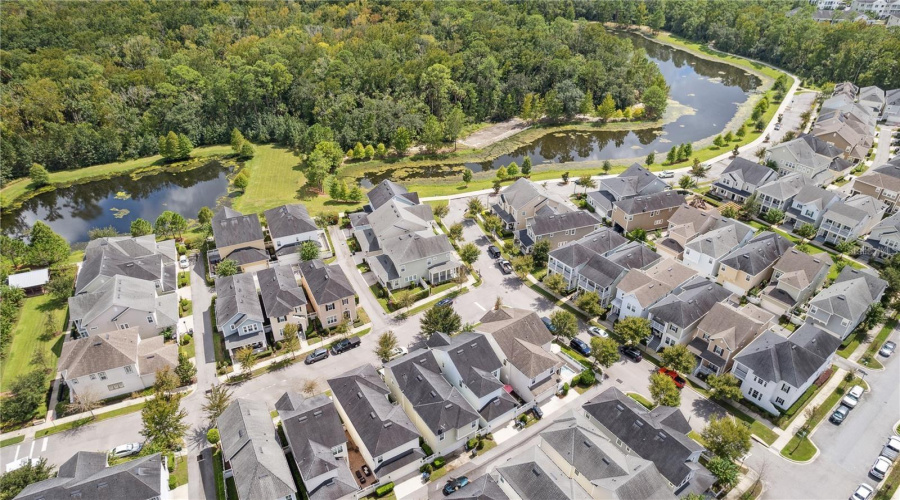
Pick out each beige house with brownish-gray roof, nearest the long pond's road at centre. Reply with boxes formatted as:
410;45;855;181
491;177;572;233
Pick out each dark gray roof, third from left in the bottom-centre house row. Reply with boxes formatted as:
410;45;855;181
328;364;419;465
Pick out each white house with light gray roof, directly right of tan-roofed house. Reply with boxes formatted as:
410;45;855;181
681;216;755;278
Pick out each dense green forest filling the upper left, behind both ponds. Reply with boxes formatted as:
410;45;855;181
0;1;665;179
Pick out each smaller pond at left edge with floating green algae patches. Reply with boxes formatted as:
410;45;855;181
0;161;228;243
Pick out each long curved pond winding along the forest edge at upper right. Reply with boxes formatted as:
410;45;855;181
360;32;760;187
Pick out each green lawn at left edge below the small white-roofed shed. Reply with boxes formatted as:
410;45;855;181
0;295;67;400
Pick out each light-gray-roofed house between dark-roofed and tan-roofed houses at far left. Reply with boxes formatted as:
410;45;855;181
69;274;178;339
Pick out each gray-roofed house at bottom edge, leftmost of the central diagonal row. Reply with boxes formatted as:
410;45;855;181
216;399;300;500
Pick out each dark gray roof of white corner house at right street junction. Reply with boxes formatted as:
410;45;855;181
735;323;841;387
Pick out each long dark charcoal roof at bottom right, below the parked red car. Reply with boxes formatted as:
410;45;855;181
582;387;703;485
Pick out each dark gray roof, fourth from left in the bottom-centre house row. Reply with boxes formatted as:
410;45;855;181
384;350;486;435
